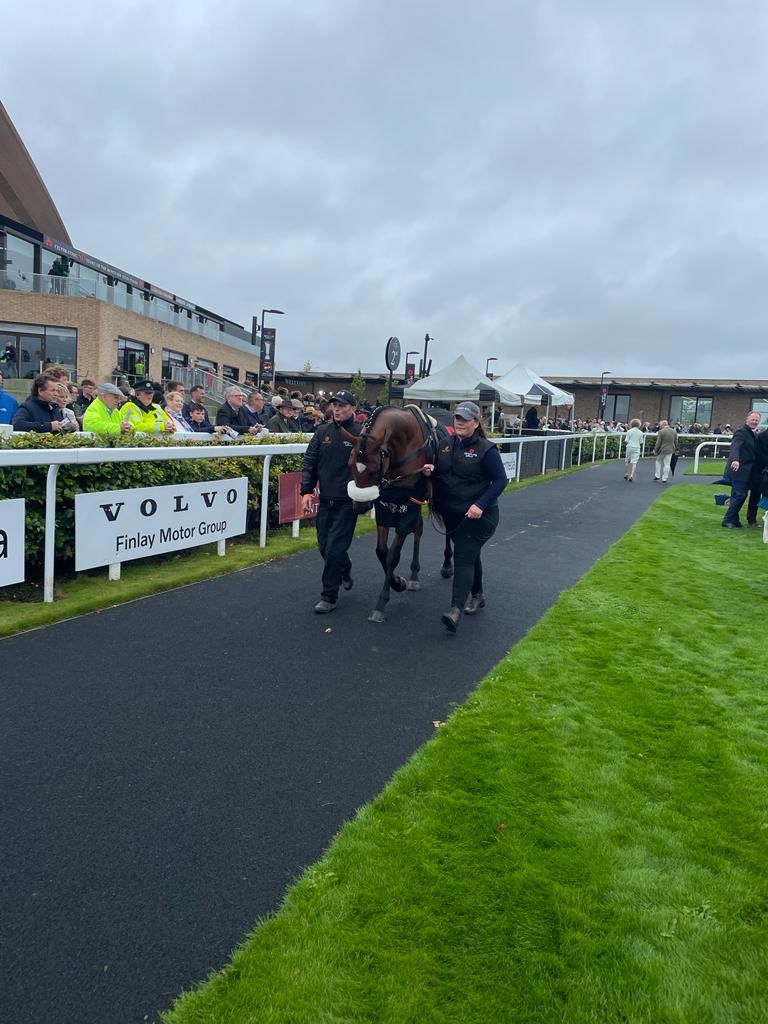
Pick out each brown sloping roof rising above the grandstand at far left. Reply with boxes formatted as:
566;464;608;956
0;102;72;245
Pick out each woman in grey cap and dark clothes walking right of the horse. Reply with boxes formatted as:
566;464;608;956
425;401;507;633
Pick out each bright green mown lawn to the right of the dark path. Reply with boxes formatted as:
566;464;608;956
166;486;768;1024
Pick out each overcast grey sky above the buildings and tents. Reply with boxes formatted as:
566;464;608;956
6;0;768;378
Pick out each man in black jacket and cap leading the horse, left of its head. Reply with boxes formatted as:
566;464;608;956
301;391;362;615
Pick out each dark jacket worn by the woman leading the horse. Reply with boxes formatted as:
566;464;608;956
435;433;507;517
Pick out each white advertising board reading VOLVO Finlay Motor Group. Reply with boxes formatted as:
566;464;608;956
75;476;248;570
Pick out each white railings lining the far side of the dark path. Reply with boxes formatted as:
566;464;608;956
0;433;730;602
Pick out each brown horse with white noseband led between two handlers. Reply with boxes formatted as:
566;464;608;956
347;406;437;623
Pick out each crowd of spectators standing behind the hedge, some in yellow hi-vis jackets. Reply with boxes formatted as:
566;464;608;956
0;366;382;438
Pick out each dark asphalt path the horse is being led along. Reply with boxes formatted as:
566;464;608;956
0;463;704;1024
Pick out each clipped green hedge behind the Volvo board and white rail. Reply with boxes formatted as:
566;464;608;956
0;434;309;579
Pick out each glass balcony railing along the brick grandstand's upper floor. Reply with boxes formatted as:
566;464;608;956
0;270;253;352
